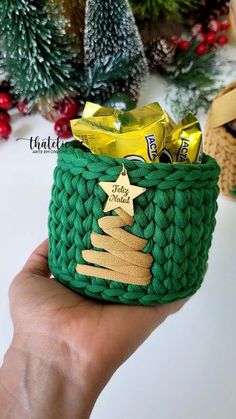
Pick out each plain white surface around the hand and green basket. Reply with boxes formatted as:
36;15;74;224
0;54;236;419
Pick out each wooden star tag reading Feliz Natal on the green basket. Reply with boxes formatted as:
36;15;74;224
99;165;146;216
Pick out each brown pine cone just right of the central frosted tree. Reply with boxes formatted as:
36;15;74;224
145;37;176;71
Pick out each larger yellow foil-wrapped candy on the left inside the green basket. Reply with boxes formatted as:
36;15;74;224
71;102;174;162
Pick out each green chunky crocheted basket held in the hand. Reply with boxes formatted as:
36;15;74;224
49;141;220;305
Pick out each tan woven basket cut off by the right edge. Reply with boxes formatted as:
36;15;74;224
204;82;236;199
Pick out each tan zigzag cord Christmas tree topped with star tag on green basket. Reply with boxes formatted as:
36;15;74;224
76;165;153;285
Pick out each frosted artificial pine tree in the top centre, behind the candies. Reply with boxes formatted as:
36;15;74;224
84;0;148;99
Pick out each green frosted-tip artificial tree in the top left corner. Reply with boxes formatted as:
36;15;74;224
0;0;76;108
